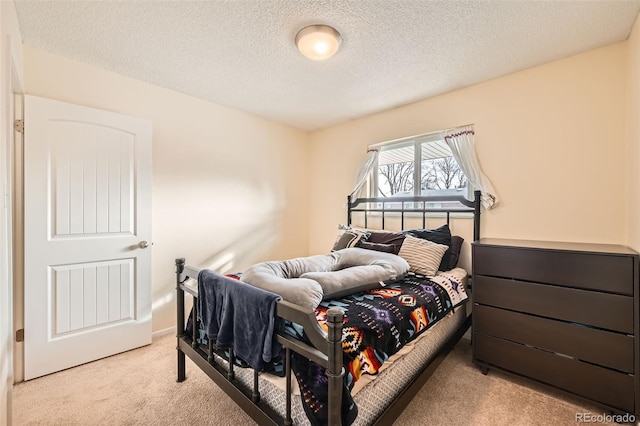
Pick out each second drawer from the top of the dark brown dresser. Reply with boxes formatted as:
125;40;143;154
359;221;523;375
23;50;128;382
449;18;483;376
473;275;634;334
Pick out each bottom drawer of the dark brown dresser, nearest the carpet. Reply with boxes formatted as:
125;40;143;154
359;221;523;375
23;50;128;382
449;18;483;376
474;333;635;413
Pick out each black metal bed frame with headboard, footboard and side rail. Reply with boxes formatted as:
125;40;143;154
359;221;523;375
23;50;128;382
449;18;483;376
176;191;480;426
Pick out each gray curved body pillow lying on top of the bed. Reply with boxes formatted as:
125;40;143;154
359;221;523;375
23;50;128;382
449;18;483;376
241;248;409;309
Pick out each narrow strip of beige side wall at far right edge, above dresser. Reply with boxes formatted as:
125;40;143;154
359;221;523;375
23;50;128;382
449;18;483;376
626;17;640;251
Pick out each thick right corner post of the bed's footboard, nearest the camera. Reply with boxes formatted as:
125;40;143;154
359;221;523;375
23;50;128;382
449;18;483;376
327;308;344;426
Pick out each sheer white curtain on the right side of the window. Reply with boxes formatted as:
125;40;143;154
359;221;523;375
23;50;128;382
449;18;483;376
444;126;498;209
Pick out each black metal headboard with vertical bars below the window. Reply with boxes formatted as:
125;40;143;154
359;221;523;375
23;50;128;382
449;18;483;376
347;191;480;241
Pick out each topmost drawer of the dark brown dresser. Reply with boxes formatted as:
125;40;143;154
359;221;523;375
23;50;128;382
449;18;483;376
473;245;634;295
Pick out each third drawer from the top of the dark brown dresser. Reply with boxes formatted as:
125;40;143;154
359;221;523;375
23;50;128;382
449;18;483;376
473;305;634;373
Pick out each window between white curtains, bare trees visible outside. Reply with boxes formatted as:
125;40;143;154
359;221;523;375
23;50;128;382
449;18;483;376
371;134;472;199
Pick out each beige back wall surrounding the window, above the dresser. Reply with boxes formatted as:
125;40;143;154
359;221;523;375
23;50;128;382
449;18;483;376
309;42;627;260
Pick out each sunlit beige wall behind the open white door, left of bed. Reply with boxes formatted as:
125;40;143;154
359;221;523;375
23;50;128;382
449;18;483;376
24;45;309;331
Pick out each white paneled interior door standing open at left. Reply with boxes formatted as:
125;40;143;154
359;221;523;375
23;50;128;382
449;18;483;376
24;96;152;380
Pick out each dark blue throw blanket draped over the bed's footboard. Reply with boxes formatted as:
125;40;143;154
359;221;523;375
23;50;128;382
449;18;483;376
198;269;281;371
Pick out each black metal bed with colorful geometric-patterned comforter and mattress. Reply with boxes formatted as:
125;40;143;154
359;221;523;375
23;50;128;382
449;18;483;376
176;191;480;425
